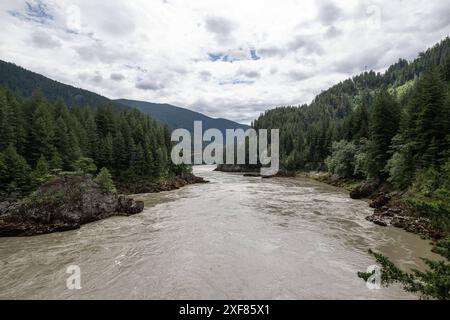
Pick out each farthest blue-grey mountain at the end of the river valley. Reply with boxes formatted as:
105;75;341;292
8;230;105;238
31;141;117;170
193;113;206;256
115;99;249;134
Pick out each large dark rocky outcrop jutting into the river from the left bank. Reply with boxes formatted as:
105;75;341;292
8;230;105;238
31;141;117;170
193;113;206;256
0;176;144;237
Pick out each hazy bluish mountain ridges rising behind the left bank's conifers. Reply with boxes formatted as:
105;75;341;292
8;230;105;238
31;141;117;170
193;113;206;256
0;60;249;132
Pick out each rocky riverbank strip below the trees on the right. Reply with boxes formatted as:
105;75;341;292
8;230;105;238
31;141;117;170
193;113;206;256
301;172;443;240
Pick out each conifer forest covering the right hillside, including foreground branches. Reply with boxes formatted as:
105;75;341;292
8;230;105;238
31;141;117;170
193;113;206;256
253;38;450;299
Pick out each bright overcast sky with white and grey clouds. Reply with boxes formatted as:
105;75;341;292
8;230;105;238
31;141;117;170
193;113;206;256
0;0;450;123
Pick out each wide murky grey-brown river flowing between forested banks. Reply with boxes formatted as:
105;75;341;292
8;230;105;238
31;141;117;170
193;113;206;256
0;166;434;299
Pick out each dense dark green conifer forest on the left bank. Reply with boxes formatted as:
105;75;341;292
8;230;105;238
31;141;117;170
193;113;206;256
0;88;187;199
